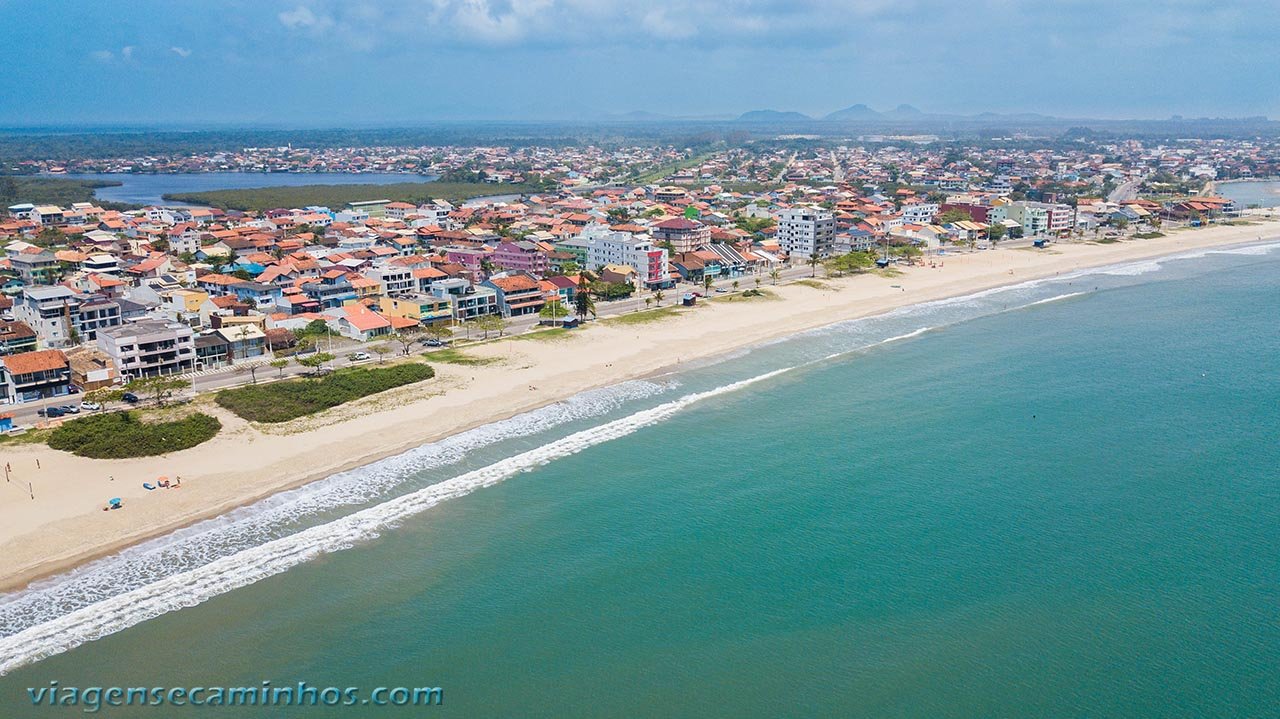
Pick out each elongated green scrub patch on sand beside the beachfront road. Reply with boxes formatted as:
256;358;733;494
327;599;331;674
215;365;435;422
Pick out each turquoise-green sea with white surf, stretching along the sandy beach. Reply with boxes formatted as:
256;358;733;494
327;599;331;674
0;243;1280;716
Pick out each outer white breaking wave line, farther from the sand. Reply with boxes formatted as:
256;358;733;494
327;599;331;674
0;367;795;676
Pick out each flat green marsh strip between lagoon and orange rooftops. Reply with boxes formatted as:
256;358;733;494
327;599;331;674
164;182;543;211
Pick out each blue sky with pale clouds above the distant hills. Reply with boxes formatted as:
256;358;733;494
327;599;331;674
0;0;1280;127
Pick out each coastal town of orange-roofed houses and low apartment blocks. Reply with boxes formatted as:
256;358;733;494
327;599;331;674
0;138;1276;431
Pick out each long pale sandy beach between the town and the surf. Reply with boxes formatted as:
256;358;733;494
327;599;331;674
0;224;1276;590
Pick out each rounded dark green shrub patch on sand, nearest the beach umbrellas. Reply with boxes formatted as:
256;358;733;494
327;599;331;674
49;412;223;459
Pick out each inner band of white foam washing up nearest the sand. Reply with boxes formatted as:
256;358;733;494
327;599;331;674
0;381;678;636
